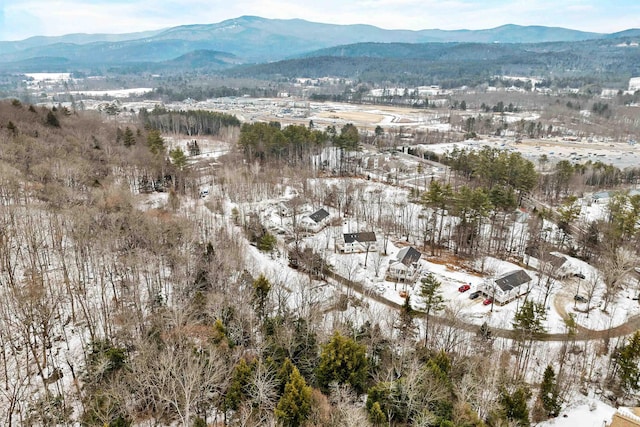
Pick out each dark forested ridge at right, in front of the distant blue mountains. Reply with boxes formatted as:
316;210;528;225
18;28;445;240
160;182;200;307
226;39;640;87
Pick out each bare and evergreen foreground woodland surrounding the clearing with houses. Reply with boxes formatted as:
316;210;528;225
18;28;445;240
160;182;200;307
0;100;640;427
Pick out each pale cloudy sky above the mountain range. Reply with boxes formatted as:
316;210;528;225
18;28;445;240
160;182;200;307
0;0;640;40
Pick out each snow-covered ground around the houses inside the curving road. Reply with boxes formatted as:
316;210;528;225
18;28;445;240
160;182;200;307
250;178;640;333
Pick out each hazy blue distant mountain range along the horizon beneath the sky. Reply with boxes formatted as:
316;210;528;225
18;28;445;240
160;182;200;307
0;16;640;72
